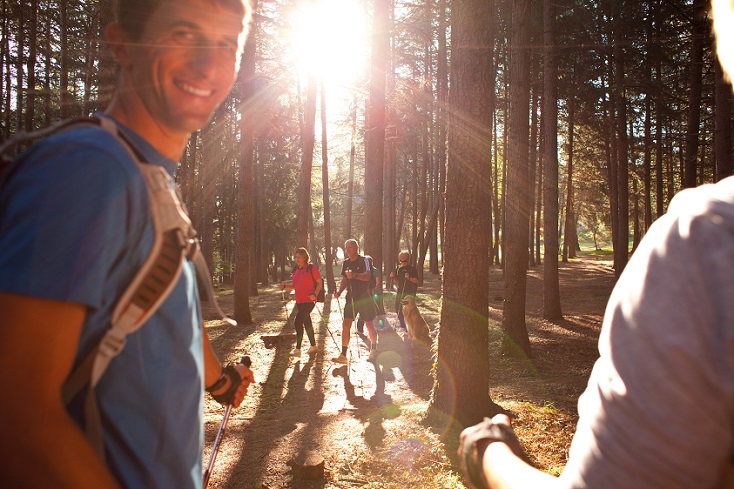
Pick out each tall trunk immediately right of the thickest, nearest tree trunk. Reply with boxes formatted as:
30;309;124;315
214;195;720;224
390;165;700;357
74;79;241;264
502;0;533;357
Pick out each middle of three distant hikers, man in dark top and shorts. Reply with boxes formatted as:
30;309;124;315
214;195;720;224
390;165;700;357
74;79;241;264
333;239;377;364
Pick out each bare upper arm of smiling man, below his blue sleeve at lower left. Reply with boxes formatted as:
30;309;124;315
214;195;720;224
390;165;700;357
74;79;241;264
0;292;118;488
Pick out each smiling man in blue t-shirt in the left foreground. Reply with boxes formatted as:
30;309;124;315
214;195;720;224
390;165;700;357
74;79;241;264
0;0;253;488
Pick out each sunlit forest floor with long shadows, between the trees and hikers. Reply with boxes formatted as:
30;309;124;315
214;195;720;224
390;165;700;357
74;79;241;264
204;253;614;489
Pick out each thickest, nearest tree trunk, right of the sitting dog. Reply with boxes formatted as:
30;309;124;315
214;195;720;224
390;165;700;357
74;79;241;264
430;0;506;425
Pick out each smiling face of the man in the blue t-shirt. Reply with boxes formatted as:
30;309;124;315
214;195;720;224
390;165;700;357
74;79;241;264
123;0;244;134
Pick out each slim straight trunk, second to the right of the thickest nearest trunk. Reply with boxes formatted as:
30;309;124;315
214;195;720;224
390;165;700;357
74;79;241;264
542;0;563;320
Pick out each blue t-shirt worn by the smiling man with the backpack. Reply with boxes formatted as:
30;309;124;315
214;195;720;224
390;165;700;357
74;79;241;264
0;117;204;488
